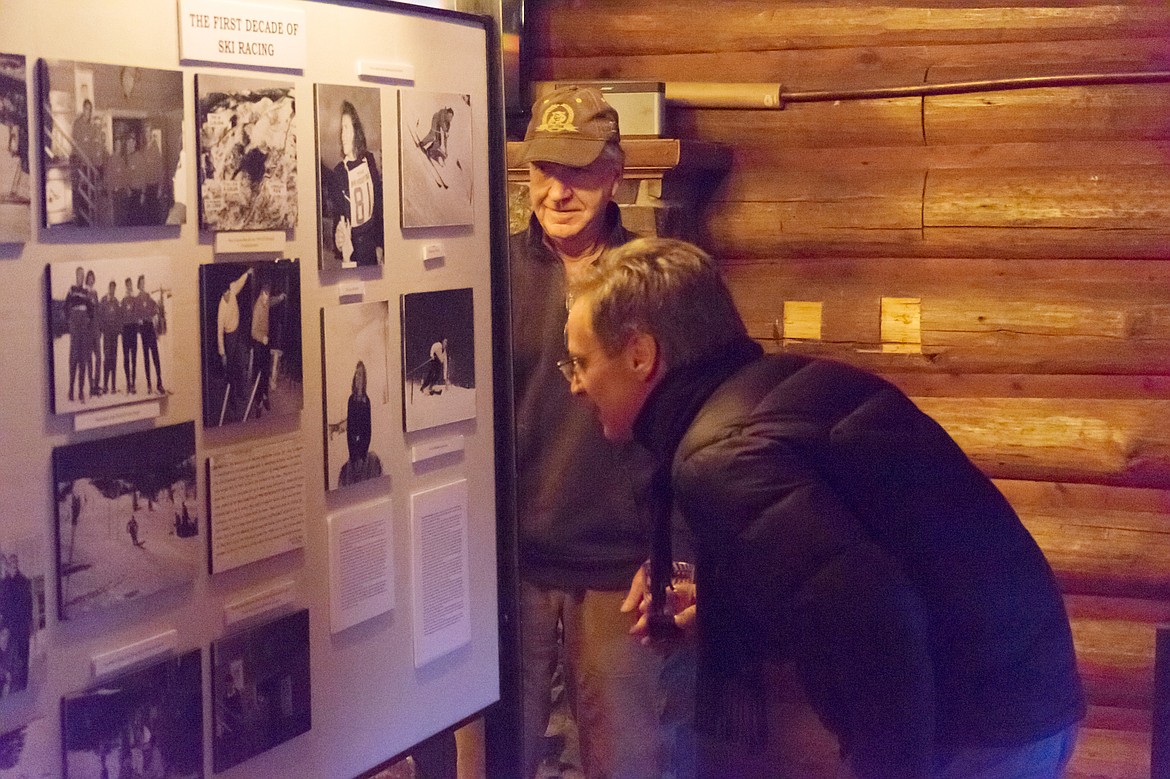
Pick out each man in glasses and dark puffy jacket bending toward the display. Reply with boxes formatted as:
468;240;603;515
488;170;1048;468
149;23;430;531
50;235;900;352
567;239;1085;779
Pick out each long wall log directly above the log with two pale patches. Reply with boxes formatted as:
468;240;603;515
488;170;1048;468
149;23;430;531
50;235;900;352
708;165;1170;257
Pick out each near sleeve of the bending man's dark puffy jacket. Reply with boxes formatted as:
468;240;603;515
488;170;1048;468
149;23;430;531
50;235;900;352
674;432;935;779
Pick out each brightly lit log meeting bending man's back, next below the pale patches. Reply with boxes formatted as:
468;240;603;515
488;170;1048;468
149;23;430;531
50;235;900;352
914;398;1170;488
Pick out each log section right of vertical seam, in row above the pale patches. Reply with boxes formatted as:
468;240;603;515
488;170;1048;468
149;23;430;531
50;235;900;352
922;164;1170;225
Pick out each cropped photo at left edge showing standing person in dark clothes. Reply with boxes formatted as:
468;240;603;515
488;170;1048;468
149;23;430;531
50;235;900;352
0;536;47;698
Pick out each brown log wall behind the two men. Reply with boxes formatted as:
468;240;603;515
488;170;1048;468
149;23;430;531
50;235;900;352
524;0;1170;779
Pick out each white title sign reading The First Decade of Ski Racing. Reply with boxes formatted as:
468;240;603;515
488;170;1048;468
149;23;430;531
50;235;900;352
179;0;307;70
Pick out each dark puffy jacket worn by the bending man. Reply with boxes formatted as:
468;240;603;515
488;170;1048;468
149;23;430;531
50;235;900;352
635;348;1085;779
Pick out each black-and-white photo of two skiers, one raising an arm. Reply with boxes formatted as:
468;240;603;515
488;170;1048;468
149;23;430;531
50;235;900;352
199;260;304;428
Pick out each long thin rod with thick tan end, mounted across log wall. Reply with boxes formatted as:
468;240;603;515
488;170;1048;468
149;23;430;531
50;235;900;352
666;70;1170;110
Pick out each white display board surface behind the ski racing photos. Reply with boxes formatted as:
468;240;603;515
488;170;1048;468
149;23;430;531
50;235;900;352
0;0;505;779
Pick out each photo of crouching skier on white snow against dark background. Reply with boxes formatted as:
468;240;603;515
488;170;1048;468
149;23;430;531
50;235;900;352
402;287;475;433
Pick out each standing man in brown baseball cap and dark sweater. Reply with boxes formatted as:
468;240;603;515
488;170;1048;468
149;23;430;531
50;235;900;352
510;87;693;779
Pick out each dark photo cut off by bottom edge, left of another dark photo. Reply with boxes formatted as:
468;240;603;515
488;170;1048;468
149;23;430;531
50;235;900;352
61;649;204;779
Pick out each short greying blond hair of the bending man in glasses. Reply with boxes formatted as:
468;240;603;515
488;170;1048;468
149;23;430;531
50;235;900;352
570;239;746;368
